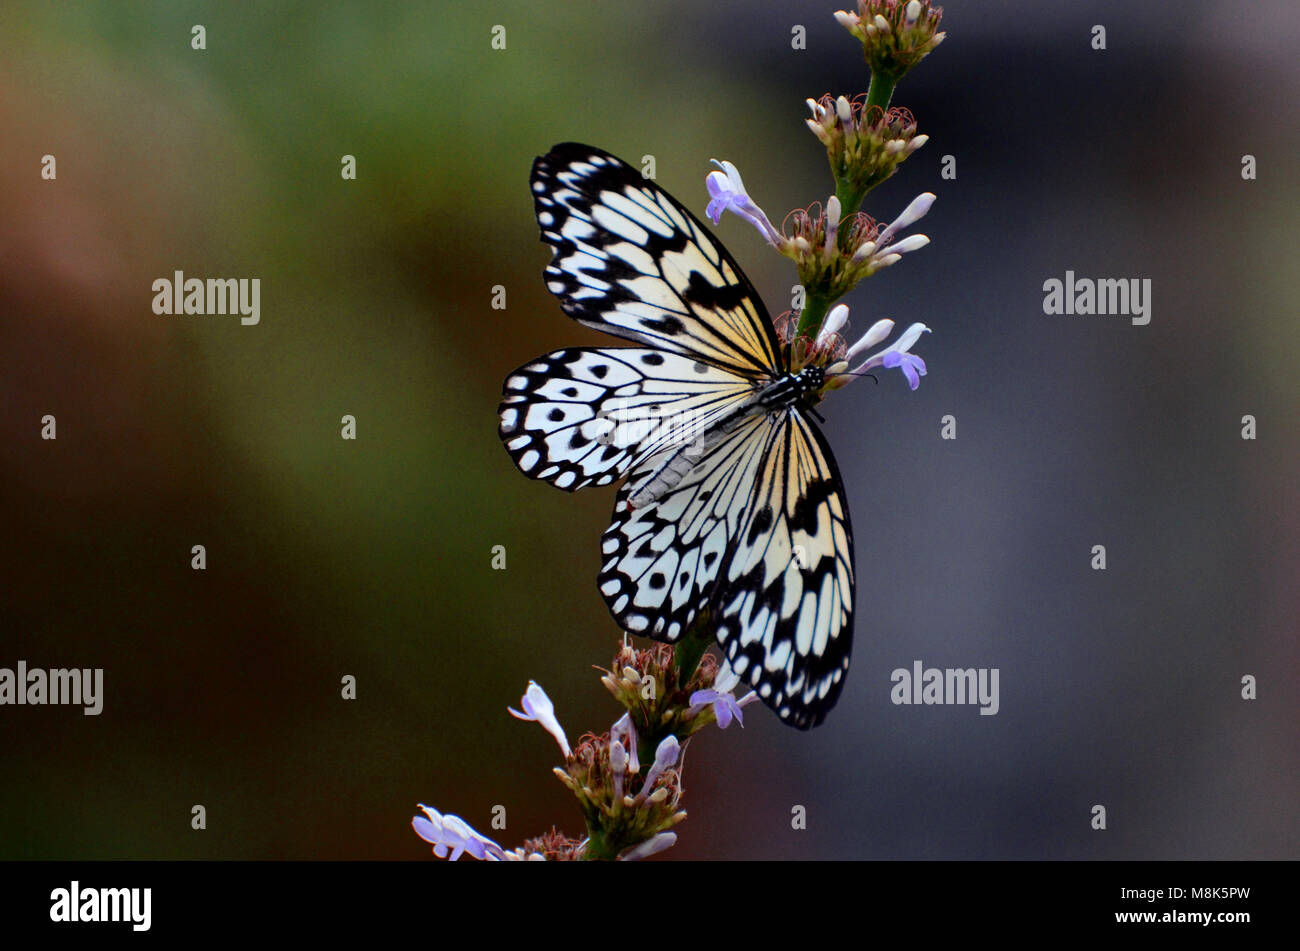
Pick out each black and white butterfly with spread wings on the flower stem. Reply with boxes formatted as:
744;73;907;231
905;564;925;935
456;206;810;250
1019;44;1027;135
501;143;854;729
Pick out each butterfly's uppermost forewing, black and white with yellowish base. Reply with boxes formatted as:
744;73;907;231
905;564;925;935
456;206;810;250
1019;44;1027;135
532;143;780;375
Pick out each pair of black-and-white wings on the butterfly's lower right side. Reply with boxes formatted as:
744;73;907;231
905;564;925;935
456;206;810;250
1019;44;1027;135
598;408;854;729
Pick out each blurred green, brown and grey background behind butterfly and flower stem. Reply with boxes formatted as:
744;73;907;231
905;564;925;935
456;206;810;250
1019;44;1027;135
0;0;1300;859
